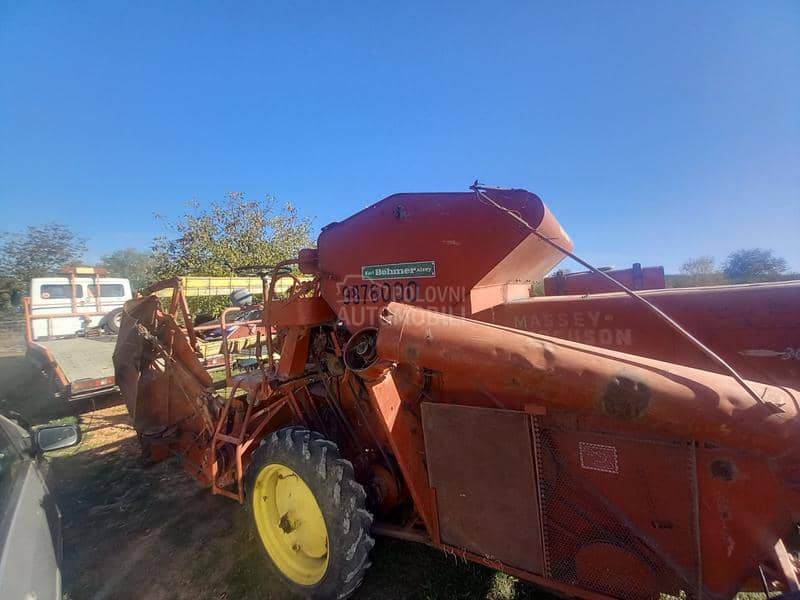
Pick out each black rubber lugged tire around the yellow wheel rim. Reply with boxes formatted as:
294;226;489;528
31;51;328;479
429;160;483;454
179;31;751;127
245;427;375;600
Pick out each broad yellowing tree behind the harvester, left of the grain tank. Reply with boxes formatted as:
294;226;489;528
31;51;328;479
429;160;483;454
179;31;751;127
153;192;311;279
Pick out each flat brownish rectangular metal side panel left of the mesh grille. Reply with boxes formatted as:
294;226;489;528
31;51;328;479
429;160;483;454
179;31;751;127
422;403;544;574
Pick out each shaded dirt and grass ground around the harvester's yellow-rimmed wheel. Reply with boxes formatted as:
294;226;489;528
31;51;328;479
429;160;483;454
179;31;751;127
0;355;549;600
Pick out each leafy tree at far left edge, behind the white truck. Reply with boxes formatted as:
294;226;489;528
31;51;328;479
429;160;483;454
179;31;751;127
0;223;86;303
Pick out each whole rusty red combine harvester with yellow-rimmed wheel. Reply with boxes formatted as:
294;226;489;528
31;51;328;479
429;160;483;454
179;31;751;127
115;186;800;598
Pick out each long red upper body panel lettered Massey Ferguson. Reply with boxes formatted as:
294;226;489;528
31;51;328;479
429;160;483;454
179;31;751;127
472;281;800;387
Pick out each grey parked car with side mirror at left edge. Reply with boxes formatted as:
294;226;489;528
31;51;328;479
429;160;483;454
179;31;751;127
0;415;80;600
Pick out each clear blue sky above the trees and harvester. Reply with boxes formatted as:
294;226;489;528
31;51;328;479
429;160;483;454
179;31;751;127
0;0;800;270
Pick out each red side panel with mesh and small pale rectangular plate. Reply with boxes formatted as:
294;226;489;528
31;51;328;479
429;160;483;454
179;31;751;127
533;416;703;600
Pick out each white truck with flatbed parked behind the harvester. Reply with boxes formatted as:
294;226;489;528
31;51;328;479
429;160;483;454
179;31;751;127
23;267;132;400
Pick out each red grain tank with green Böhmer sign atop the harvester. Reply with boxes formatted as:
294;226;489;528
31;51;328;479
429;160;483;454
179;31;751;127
312;190;572;331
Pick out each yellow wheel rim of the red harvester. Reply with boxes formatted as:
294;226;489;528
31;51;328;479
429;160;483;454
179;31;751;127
253;463;328;585
